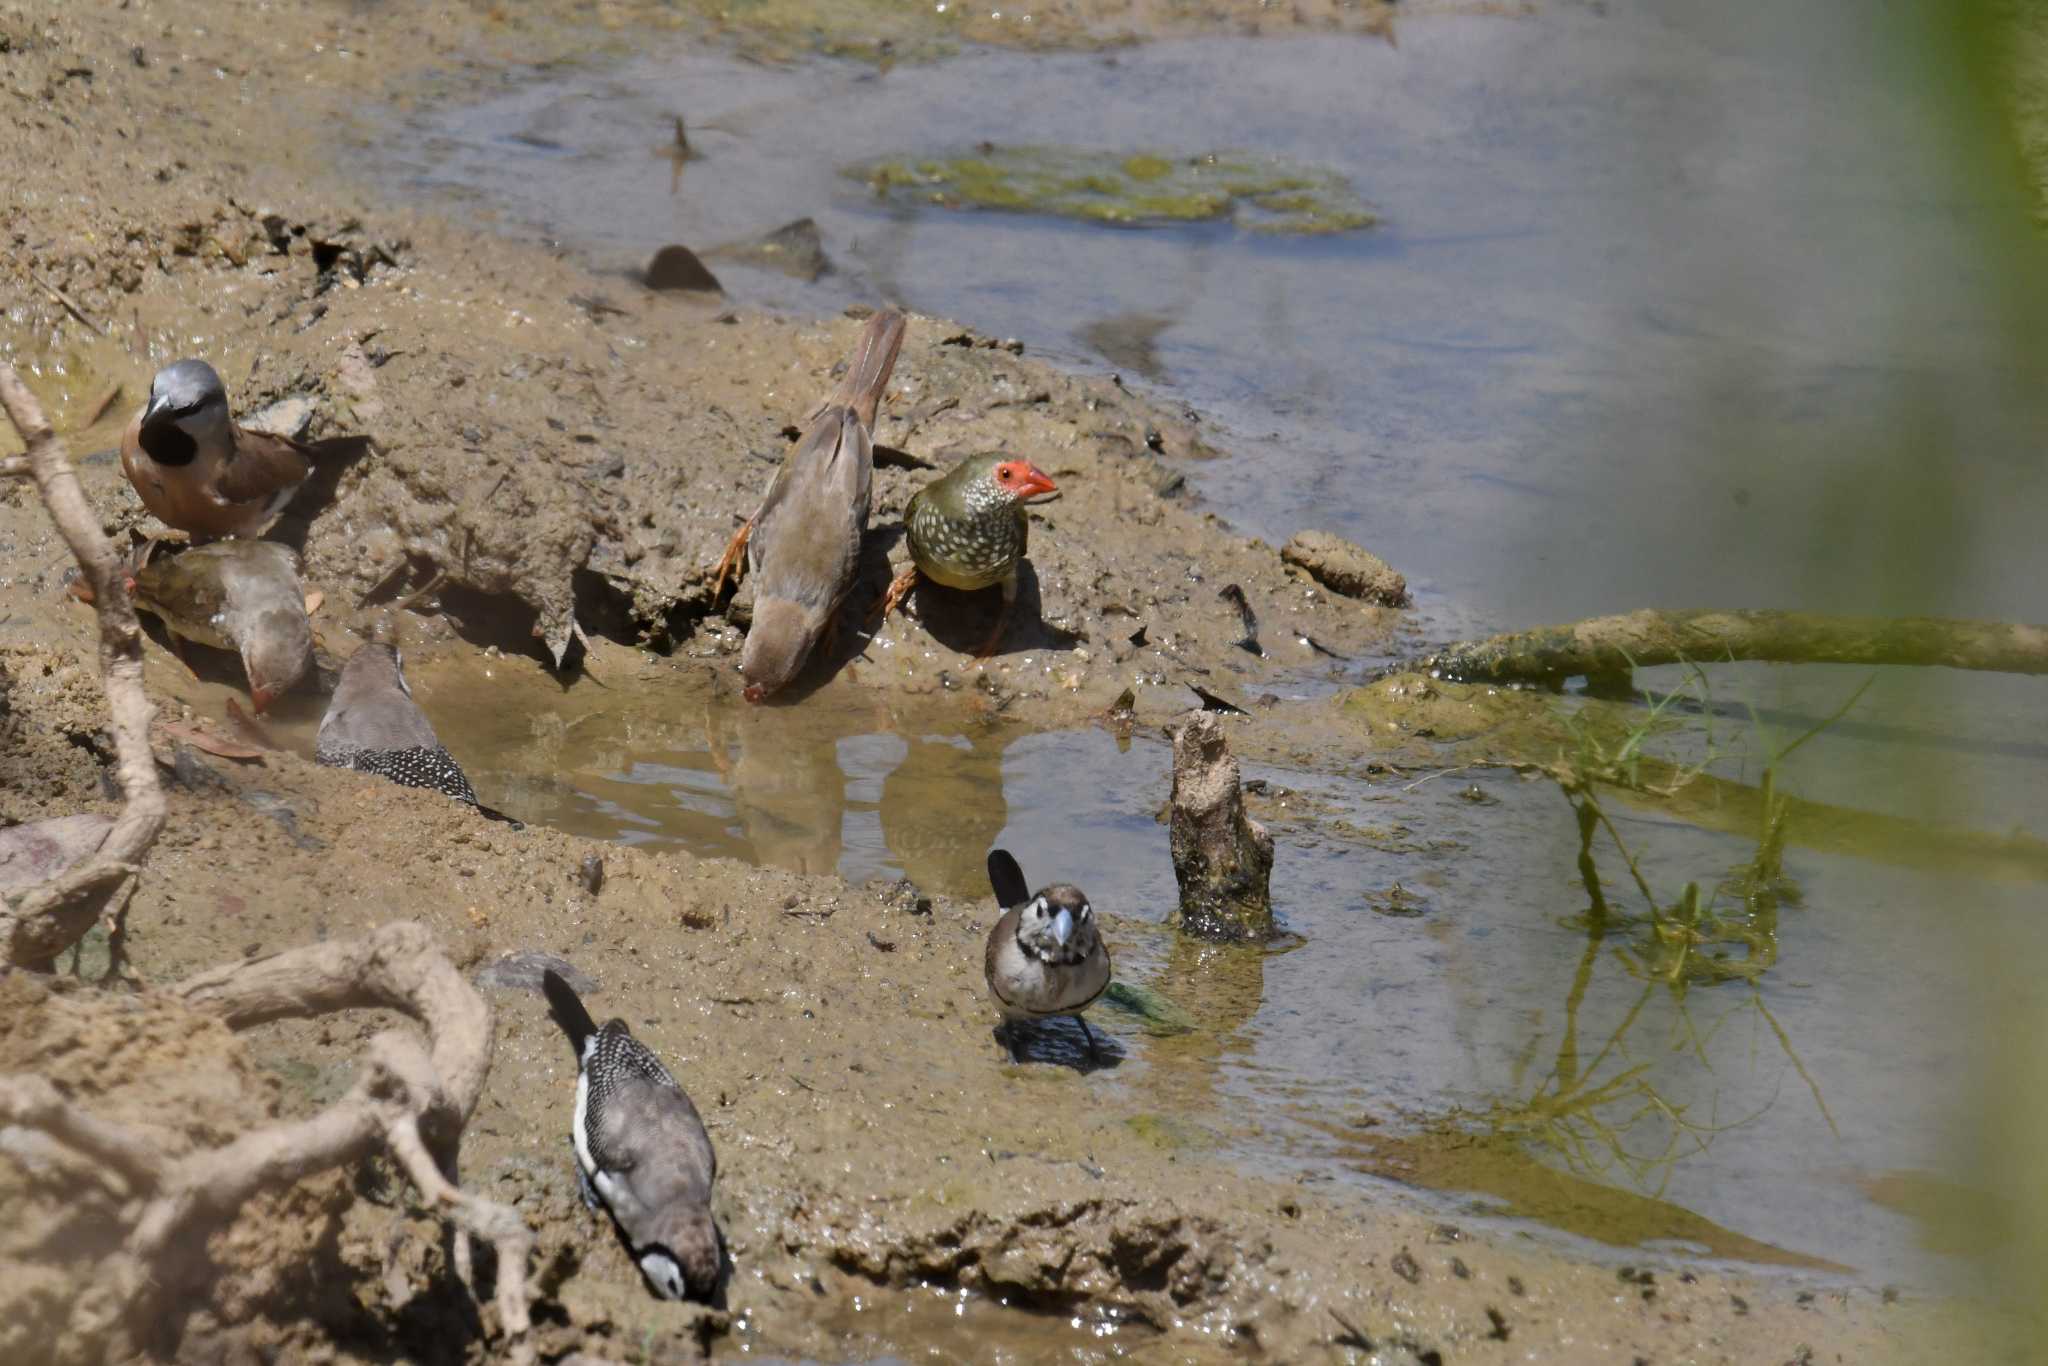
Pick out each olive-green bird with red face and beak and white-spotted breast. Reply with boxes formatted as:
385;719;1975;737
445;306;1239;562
877;453;1059;659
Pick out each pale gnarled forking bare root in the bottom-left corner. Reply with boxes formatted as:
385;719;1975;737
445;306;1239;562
0;924;537;1362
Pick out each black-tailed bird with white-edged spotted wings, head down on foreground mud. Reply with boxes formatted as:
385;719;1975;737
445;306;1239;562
541;969;723;1300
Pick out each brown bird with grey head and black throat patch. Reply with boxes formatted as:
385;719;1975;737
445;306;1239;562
121;358;313;537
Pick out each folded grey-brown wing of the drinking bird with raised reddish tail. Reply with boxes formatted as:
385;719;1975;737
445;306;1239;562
748;405;874;606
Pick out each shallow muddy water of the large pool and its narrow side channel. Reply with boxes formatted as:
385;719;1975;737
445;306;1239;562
352;4;2048;1282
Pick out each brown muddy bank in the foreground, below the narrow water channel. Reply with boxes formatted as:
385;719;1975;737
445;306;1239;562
6;720;1990;1362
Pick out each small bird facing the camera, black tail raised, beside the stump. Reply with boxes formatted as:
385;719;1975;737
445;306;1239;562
981;850;1110;1061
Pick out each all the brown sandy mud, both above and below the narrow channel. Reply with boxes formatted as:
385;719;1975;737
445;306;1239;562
0;0;1998;1362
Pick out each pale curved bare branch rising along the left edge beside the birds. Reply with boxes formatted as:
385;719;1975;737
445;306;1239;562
0;365;164;967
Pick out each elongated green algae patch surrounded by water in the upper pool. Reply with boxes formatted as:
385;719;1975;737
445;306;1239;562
846;143;1378;236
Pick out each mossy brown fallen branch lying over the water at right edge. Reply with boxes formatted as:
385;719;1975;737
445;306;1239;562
1419;608;2048;686
